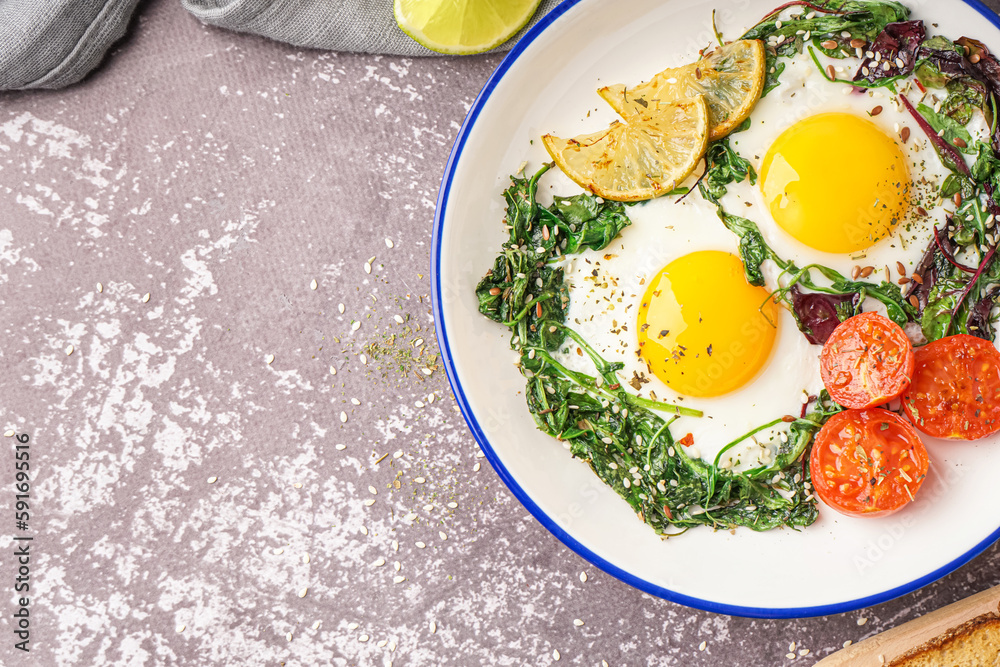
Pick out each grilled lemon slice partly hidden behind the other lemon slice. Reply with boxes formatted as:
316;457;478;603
597;39;766;141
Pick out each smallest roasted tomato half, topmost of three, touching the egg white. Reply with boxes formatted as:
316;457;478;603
820;313;914;409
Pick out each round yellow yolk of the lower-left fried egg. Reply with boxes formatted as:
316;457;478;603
637;250;778;396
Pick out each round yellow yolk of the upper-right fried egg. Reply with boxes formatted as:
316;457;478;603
760;113;910;253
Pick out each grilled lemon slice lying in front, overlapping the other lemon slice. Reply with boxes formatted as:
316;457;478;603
542;97;708;201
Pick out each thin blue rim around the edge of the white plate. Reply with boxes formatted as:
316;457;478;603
430;0;1000;619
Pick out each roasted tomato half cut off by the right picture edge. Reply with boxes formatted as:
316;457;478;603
903;334;1000;440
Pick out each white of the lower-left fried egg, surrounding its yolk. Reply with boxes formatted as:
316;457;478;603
562;195;823;472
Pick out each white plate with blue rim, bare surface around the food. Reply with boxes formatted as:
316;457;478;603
431;0;1000;618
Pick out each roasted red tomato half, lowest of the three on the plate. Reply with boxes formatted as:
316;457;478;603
809;408;930;516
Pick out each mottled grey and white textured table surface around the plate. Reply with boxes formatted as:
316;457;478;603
0;0;1000;666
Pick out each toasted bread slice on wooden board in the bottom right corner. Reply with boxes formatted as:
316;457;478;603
889;614;1000;667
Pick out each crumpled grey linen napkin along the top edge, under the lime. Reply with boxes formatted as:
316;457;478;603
0;0;559;90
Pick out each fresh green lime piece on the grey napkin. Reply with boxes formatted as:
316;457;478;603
393;0;541;55
